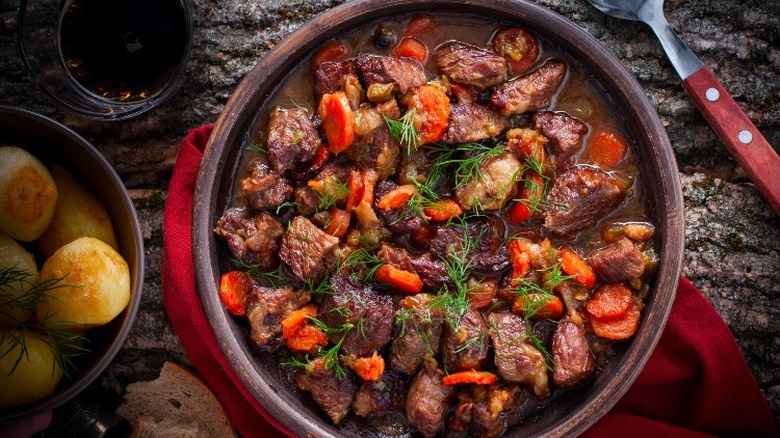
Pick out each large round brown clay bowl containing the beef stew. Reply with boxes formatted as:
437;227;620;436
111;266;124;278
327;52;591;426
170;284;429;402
193;0;683;437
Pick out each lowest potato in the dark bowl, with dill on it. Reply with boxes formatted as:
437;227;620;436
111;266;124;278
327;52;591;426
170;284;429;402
0;330;62;409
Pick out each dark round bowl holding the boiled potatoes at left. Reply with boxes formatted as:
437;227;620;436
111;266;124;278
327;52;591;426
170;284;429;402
0;106;144;424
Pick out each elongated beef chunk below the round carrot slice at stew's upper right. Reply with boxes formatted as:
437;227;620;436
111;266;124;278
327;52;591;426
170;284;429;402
490;59;567;117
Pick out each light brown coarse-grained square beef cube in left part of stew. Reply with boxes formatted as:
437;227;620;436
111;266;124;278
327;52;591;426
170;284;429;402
279;216;339;281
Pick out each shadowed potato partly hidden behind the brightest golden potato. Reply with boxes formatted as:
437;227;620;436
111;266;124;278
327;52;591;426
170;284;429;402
38;165;119;258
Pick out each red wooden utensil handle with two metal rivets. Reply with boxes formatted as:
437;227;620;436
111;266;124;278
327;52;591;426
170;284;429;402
683;67;780;216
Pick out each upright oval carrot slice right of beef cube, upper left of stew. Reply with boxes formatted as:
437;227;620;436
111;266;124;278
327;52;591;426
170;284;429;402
317;91;355;154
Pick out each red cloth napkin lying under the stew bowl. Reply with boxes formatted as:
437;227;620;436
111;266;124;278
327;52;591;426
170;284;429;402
162;126;778;438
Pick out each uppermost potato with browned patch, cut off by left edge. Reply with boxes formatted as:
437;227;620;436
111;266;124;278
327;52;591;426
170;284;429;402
0;146;57;242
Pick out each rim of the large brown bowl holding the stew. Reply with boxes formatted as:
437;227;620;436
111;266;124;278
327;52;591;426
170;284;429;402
192;0;684;437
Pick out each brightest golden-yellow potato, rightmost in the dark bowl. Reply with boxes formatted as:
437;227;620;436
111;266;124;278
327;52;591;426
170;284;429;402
35;237;130;331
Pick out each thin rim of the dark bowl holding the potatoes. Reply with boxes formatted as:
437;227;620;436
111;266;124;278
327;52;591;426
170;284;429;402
0;105;144;424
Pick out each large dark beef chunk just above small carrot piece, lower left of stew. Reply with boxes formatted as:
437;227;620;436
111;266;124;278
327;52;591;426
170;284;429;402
318;271;395;356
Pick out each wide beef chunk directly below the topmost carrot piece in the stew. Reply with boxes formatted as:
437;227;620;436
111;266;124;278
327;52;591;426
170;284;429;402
355;55;427;94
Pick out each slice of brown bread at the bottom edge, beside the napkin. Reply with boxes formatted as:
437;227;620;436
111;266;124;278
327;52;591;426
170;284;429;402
116;362;236;438
